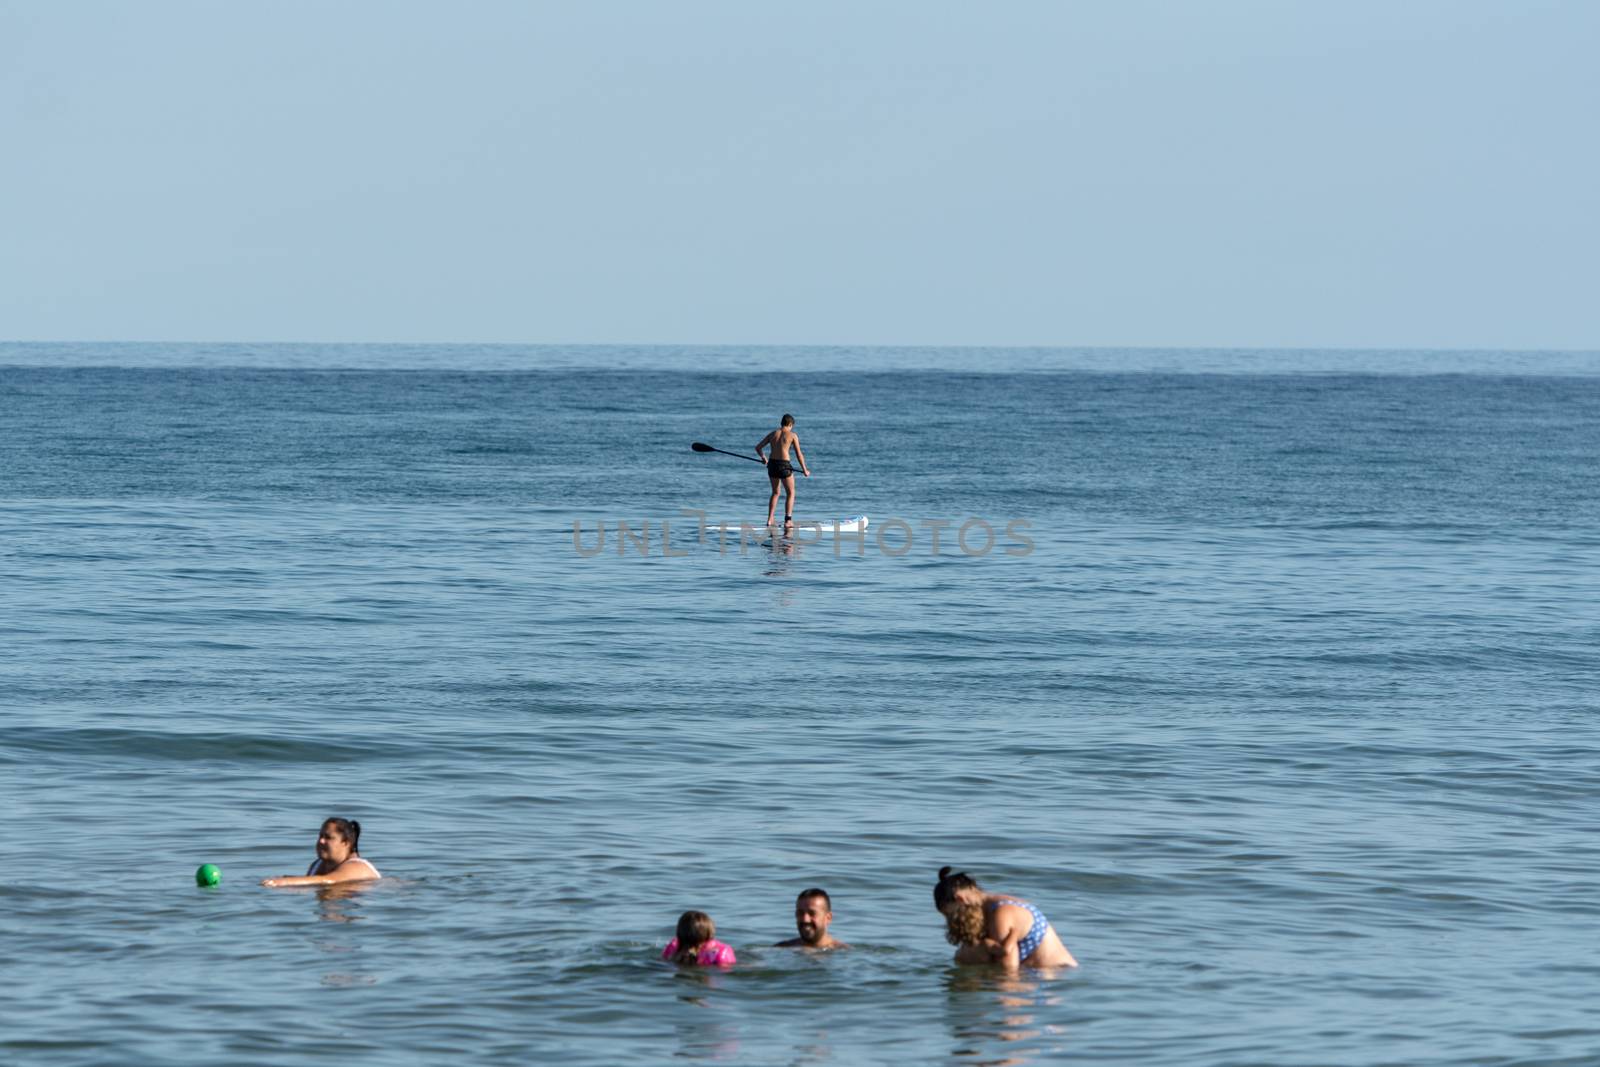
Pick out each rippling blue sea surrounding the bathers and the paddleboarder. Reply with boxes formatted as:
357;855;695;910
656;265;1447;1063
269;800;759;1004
0;342;1600;1067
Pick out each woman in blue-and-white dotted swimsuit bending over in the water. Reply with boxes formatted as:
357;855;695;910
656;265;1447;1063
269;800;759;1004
933;867;1078;968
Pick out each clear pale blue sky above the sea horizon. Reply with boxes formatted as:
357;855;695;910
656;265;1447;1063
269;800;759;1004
0;0;1600;349
